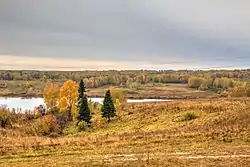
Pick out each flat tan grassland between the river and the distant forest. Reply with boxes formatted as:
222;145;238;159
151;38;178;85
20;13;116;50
0;81;219;99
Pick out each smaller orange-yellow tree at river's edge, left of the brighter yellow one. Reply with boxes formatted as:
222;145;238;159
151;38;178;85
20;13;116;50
43;83;60;109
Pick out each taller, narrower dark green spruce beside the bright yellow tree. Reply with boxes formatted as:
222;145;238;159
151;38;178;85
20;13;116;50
77;80;91;125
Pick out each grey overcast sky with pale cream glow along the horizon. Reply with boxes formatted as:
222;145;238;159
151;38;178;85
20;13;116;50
0;0;250;69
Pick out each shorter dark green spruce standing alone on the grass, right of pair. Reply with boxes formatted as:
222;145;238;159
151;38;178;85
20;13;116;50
101;90;116;122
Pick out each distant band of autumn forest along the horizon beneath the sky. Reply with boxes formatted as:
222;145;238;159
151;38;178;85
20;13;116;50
0;69;250;96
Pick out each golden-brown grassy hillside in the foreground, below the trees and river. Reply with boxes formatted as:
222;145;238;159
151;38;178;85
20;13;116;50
0;99;250;167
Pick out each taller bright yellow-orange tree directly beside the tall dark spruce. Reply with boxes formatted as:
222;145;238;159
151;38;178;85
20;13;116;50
58;80;78;119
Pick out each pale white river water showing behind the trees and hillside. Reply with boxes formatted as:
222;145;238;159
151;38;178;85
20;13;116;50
0;97;169;111
